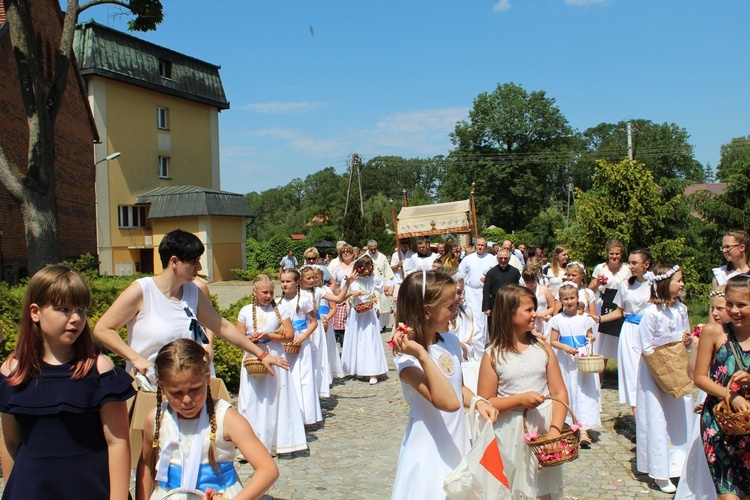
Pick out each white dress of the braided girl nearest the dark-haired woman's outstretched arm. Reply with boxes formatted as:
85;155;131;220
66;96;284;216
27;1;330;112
237;305;307;455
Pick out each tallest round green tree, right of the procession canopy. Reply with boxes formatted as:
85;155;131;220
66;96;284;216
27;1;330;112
438;83;580;230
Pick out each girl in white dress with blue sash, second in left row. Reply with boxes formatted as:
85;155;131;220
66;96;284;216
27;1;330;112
279;269;323;425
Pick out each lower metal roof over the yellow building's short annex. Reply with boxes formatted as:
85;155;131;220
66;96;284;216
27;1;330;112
140;185;255;219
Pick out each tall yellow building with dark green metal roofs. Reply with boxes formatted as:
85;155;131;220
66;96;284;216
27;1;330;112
75;21;253;281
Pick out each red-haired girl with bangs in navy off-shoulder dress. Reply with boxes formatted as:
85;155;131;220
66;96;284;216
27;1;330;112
0;266;135;500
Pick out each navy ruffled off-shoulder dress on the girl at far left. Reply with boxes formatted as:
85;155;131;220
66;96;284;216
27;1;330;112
0;363;135;500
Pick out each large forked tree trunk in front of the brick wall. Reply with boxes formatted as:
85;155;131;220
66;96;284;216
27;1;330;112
0;0;163;273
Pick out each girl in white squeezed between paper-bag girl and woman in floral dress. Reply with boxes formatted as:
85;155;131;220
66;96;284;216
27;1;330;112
675;286;731;500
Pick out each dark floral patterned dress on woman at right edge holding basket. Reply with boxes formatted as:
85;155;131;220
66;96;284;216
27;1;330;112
701;323;750;497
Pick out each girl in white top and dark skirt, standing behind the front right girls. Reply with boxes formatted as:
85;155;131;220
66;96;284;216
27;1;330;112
589;240;630;366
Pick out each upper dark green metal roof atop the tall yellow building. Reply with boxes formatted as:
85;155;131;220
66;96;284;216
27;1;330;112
73;20;229;110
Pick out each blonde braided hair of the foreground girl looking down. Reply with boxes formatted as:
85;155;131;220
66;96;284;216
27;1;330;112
149;339;219;476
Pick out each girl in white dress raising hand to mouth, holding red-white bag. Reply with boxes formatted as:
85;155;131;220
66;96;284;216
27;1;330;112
392;271;497;500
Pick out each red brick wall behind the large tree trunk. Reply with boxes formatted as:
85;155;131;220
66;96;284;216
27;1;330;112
0;0;96;278
